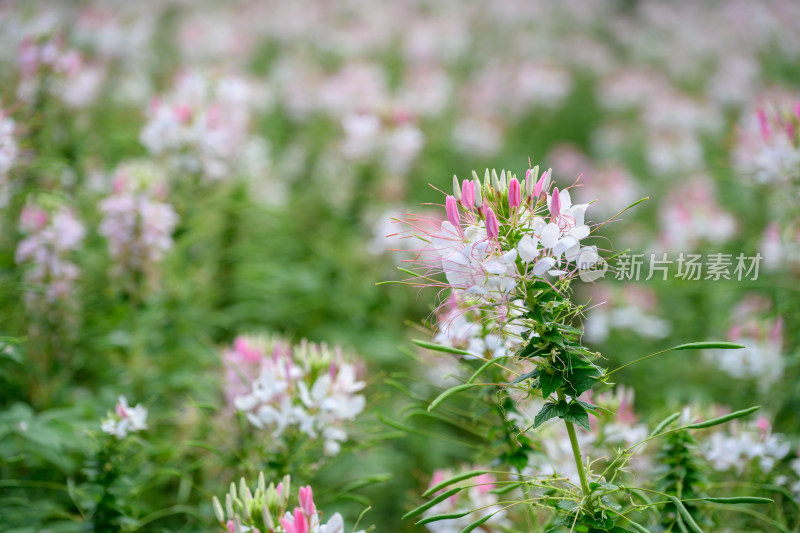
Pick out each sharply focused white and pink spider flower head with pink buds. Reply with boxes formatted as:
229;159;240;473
406;167;600;332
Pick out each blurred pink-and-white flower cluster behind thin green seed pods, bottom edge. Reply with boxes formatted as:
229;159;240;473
422;467;511;533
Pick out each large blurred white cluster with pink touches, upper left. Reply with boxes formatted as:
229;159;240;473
140;72;268;179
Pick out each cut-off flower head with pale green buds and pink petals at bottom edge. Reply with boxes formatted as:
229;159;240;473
212;472;362;533
